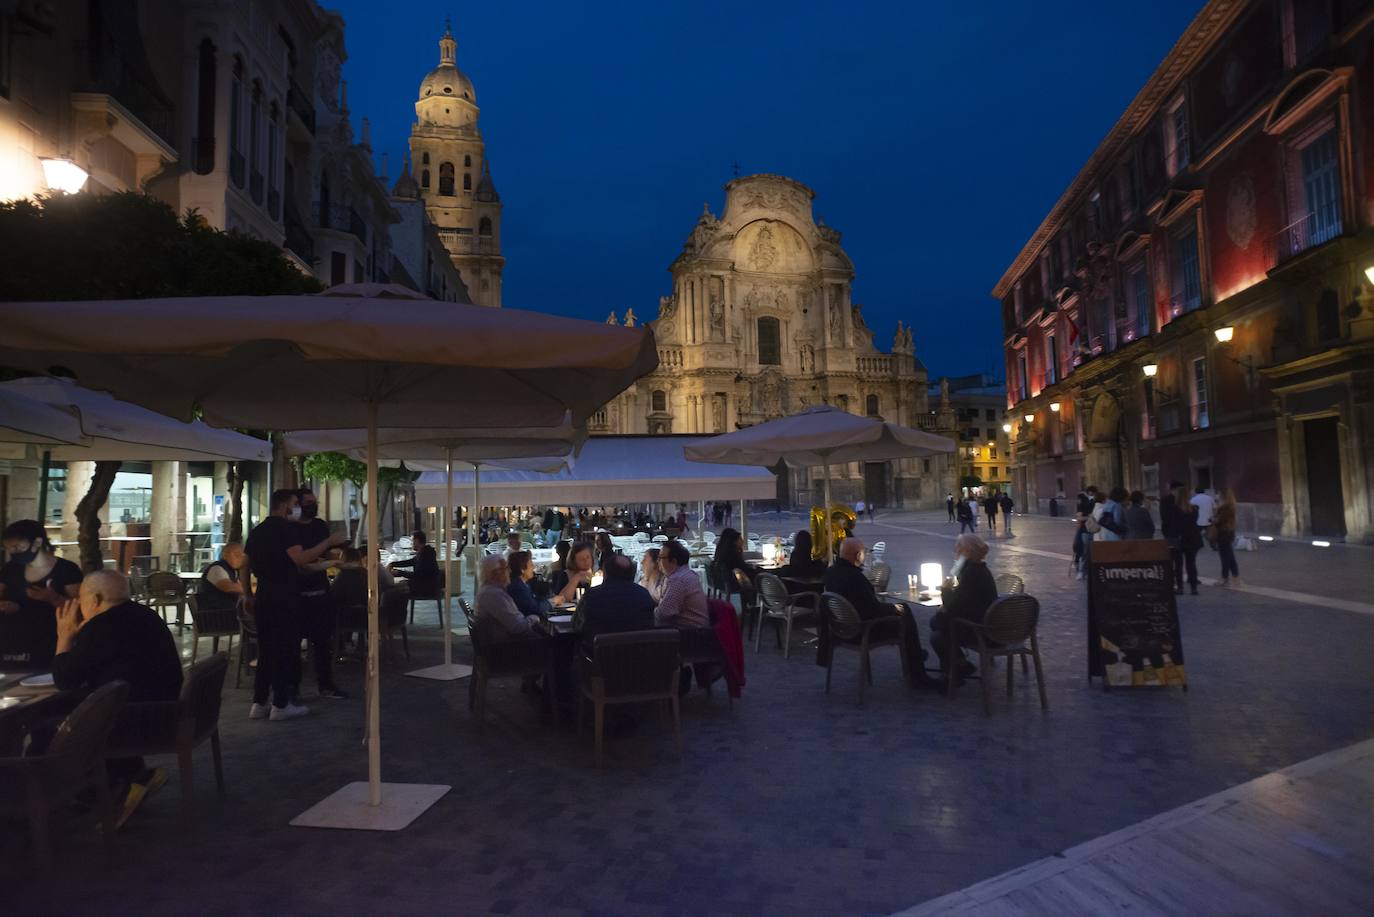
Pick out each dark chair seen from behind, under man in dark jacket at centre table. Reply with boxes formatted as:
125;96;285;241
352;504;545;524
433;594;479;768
577;627;683;767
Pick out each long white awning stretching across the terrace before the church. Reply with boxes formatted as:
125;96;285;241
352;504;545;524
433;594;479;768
415;436;778;506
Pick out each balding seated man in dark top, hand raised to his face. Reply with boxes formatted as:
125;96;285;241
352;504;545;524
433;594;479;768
52;571;181;825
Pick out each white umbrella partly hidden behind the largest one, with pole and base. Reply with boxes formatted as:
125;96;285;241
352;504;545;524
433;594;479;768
282;431;587;681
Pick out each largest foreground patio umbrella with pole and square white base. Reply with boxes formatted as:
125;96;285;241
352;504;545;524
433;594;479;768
0;296;658;830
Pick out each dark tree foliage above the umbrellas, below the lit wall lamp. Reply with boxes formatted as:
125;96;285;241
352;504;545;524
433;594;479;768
0;191;322;301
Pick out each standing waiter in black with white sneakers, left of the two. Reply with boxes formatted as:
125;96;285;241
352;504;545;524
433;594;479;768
240;489;348;720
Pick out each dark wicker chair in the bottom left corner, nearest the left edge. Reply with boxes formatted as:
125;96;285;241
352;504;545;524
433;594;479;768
0;682;129;870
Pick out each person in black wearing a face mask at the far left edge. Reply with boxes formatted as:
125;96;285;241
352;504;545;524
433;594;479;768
0;520;81;670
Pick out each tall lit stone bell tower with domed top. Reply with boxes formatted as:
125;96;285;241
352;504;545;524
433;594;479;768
411;29;506;307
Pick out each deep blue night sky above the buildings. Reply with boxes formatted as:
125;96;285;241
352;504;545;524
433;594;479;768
327;0;1202;378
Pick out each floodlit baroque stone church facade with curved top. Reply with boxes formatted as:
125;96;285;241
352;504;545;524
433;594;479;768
591;175;952;507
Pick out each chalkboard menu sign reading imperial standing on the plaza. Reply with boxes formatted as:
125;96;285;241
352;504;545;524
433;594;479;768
1088;540;1187;690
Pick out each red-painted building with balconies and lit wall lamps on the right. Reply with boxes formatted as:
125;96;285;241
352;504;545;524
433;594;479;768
993;0;1374;542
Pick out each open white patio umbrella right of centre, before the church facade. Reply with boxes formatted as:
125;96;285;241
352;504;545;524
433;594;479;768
683;404;955;560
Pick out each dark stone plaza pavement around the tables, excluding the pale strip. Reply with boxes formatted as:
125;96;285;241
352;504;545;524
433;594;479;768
0;513;1374;914
